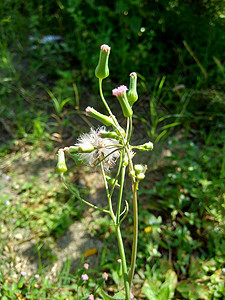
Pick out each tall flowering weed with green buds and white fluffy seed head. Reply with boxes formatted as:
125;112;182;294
56;45;153;300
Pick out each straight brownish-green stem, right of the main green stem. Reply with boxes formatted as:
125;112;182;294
129;182;138;286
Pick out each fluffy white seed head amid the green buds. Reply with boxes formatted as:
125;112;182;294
75;127;120;171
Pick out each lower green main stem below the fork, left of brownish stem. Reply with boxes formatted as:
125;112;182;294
116;226;130;300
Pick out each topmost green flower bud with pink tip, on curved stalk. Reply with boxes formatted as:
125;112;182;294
95;45;110;79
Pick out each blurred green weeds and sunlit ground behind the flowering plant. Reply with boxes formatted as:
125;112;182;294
0;0;225;300
